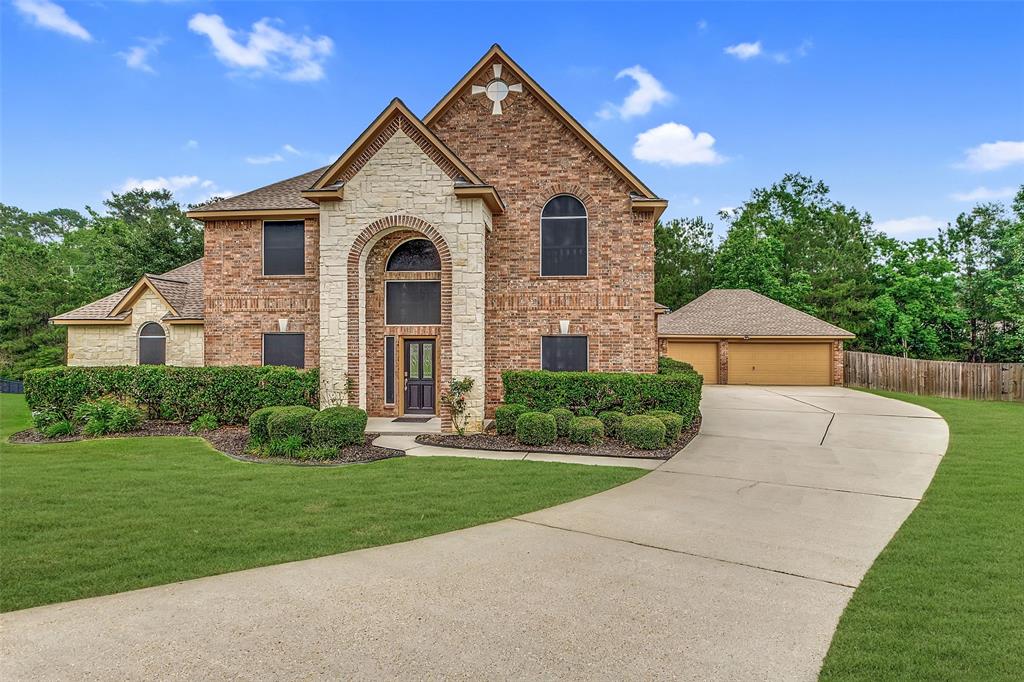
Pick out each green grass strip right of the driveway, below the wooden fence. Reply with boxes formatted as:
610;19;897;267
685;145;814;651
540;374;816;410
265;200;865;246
821;391;1024;680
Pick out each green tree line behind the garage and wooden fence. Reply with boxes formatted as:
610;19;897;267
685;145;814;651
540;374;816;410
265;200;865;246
654;173;1024;363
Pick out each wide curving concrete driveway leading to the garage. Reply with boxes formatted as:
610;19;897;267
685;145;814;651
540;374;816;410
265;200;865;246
0;386;947;680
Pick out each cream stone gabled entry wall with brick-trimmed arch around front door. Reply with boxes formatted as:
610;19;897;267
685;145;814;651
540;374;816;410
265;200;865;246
319;126;490;428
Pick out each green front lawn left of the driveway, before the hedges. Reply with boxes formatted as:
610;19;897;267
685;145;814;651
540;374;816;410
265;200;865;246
0;395;644;610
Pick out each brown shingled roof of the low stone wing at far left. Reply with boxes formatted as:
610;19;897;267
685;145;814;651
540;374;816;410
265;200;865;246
50;258;203;325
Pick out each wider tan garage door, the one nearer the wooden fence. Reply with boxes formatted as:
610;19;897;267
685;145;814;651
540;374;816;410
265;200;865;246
729;341;831;386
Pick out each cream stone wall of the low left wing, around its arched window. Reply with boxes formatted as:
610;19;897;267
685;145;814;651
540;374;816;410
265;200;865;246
68;290;203;367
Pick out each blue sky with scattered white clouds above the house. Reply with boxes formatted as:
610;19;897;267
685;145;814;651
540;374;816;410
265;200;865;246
0;0;1024;238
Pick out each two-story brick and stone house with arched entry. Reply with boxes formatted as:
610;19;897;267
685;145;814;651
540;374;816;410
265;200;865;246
54;45;667;426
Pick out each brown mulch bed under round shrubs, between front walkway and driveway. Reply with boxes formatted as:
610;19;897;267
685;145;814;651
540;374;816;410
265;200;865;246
416;415;700;460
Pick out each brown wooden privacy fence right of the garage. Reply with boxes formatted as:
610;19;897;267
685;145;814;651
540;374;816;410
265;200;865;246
843;350;1024;400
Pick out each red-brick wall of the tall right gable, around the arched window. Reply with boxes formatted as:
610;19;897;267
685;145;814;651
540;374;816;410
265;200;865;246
431;57;657;416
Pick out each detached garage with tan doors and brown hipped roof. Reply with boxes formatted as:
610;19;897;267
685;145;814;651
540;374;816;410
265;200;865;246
657;289;853;386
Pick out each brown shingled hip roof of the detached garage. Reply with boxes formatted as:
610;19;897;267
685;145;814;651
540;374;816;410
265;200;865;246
657;289;854;339
